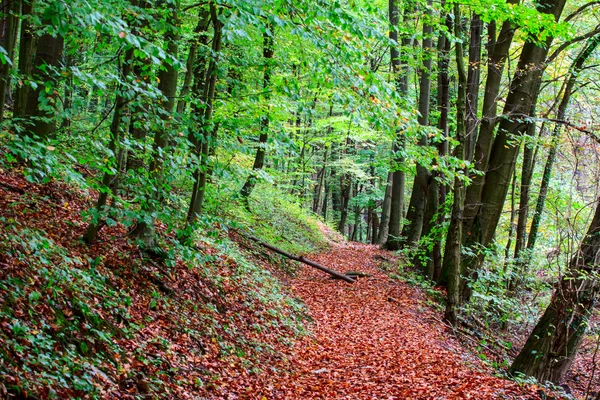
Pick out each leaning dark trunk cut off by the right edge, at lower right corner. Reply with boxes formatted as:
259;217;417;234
510;198;600;383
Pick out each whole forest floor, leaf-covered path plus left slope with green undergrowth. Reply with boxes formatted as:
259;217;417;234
0;171;595;400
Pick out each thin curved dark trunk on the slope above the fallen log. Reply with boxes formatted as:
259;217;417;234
240;24;276;209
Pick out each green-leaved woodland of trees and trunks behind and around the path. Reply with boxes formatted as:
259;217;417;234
0;0;600;397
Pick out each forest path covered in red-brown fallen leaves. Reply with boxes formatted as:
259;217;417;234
256;239;538;399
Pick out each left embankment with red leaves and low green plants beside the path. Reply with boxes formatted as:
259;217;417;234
0;170;302;399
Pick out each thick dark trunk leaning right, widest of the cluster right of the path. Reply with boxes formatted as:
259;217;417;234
462;0;565;301
